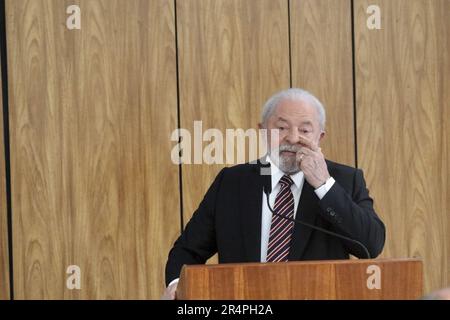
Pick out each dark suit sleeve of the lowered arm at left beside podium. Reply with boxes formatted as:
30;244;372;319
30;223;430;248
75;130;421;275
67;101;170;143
166;169;226;285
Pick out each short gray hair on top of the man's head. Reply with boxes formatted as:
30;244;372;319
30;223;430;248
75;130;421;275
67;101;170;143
261;88;325;130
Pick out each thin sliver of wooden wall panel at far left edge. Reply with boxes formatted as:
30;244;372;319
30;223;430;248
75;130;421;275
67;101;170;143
0;50;10;300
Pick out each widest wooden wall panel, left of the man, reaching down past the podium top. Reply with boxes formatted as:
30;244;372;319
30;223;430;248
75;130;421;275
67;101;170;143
6;0;180;299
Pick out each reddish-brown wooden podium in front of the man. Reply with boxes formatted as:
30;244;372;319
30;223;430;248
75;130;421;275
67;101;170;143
177;259;422;300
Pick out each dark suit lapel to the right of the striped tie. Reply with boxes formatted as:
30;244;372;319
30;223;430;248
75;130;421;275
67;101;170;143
289;180;319;261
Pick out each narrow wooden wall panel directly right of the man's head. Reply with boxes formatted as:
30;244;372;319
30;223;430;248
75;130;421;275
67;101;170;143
291;0;355;166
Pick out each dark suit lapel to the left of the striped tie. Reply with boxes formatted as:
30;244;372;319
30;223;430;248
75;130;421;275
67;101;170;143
239;164;264;262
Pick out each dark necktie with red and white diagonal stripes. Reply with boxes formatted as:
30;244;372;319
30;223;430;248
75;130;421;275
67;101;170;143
266;175;294;262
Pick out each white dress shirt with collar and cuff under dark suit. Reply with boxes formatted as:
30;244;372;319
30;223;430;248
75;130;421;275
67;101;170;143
261;157;334;262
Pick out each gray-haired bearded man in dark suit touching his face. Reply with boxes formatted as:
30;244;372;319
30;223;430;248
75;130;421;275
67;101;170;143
164;89;385;299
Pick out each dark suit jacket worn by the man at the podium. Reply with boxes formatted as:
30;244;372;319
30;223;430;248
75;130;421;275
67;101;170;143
166;160;385;284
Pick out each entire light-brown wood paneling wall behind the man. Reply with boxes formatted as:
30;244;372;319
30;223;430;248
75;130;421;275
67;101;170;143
0;0;450;299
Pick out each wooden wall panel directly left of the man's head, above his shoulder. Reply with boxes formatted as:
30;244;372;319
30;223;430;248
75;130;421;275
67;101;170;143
177;0;289;230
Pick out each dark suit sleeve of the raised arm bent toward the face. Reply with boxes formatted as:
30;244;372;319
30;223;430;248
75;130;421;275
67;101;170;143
319;169;386;258
